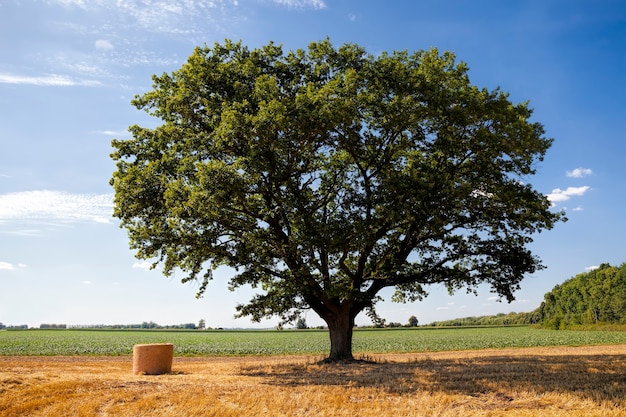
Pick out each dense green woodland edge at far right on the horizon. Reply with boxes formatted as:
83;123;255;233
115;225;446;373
536;263;626;330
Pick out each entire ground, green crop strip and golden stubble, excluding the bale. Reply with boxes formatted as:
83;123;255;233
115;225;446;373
0;327;626;417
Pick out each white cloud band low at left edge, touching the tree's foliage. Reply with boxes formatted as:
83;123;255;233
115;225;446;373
0;190;113;223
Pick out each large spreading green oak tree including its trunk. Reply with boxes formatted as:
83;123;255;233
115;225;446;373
111;39;562;360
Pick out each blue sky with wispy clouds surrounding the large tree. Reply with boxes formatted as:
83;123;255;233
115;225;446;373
0;0;626;328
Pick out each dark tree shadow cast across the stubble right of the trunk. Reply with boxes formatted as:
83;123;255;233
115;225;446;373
241;354;626;409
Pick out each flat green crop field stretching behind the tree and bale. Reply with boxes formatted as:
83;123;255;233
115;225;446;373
0;327;626;356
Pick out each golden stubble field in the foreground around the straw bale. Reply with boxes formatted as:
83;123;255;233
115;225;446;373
0;345;626;417
